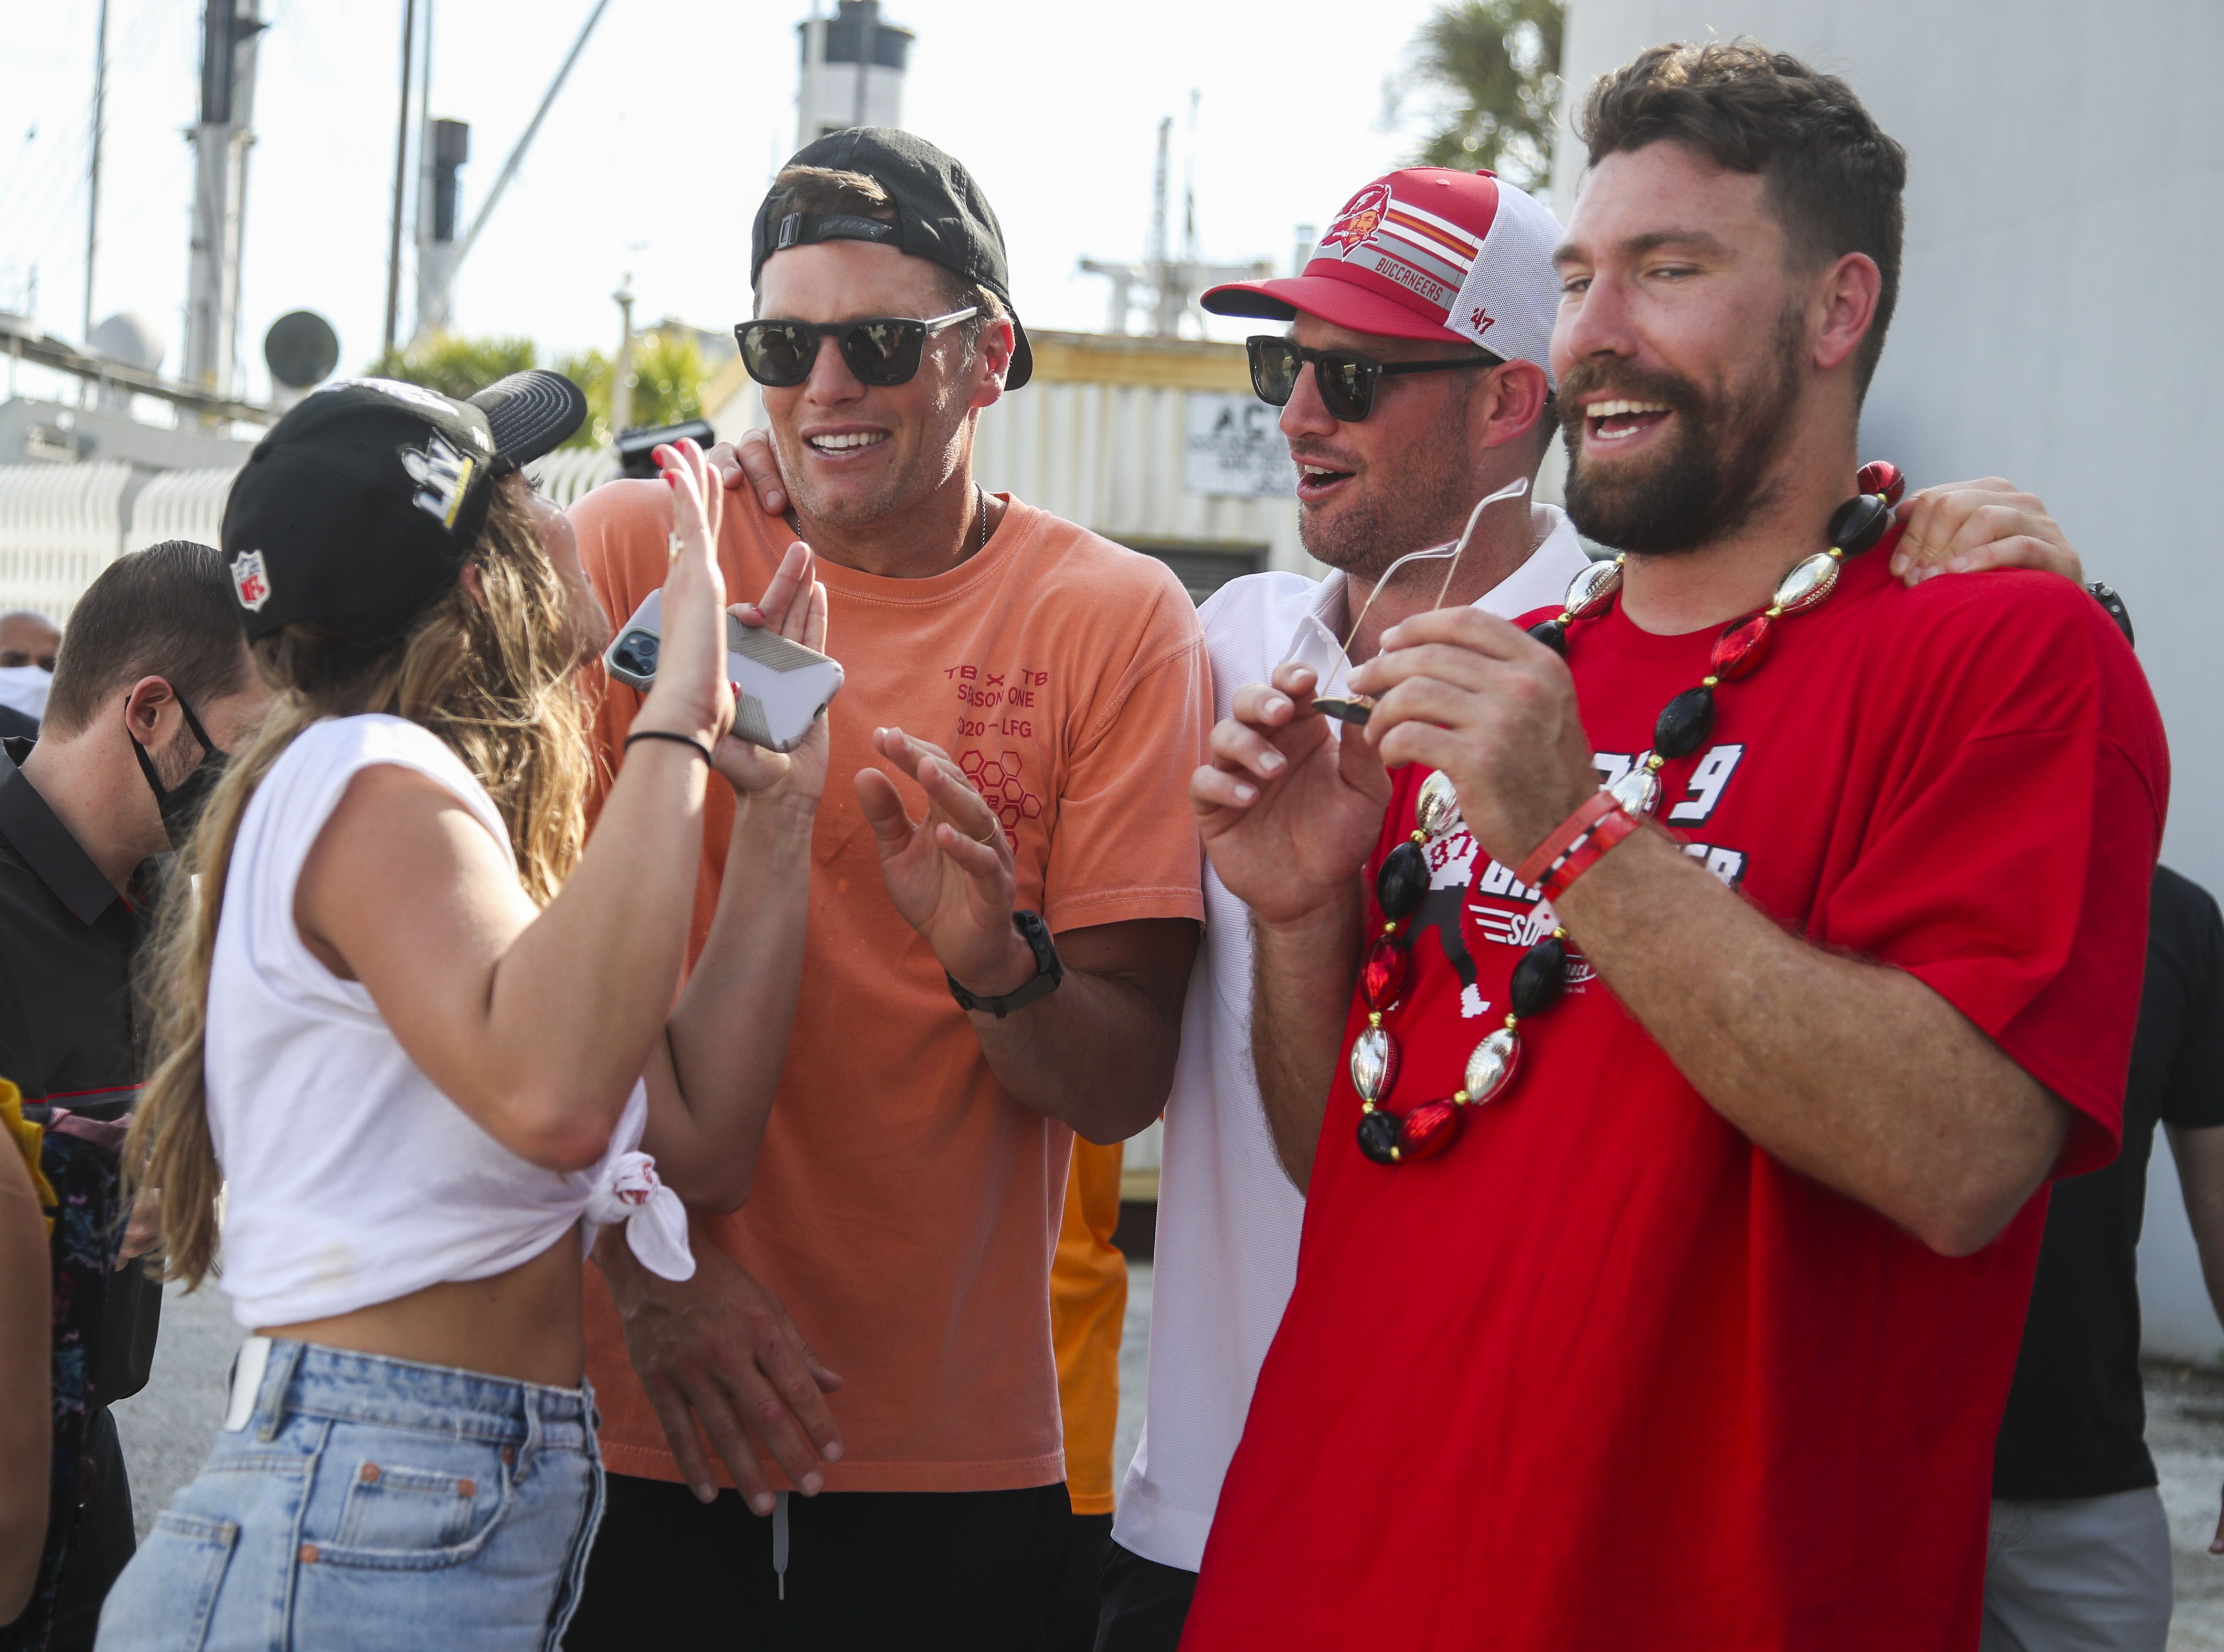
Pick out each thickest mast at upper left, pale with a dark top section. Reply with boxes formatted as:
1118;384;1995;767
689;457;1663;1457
185;0;264;407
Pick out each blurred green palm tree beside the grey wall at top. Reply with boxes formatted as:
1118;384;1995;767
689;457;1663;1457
1388;0;1563;191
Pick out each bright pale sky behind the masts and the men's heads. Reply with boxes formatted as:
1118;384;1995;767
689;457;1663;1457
0;0;1459;391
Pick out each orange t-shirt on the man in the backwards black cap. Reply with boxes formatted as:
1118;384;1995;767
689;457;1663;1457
571;483;1212;1492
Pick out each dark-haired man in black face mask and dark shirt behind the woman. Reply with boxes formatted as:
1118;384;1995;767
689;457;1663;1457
0;540;267;1652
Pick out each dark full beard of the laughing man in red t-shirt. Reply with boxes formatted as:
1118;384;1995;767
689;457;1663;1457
1559;307;1806;556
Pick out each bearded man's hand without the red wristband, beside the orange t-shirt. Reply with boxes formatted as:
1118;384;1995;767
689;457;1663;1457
1190;665;1390;938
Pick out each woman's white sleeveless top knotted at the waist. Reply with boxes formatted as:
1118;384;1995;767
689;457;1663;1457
205;716;694;1329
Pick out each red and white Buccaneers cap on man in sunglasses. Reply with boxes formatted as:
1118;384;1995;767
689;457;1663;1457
1199;167;1559;378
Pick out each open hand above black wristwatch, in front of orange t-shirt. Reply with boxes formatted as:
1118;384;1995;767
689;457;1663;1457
856;729;1036;998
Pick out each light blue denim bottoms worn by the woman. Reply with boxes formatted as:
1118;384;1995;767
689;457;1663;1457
100;1341;603;1652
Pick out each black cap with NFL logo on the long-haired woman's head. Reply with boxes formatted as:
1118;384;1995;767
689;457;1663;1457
222;369;587;649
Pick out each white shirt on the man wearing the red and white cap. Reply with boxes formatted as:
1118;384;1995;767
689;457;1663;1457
1112;505;1585;1572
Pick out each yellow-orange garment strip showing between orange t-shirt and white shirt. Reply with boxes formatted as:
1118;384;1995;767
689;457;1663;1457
1050;1136;1127;1514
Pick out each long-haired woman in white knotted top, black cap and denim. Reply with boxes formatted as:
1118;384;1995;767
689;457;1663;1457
100;374;825;1648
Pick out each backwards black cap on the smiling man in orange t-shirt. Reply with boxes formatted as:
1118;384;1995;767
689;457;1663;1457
750;127;1034;389
